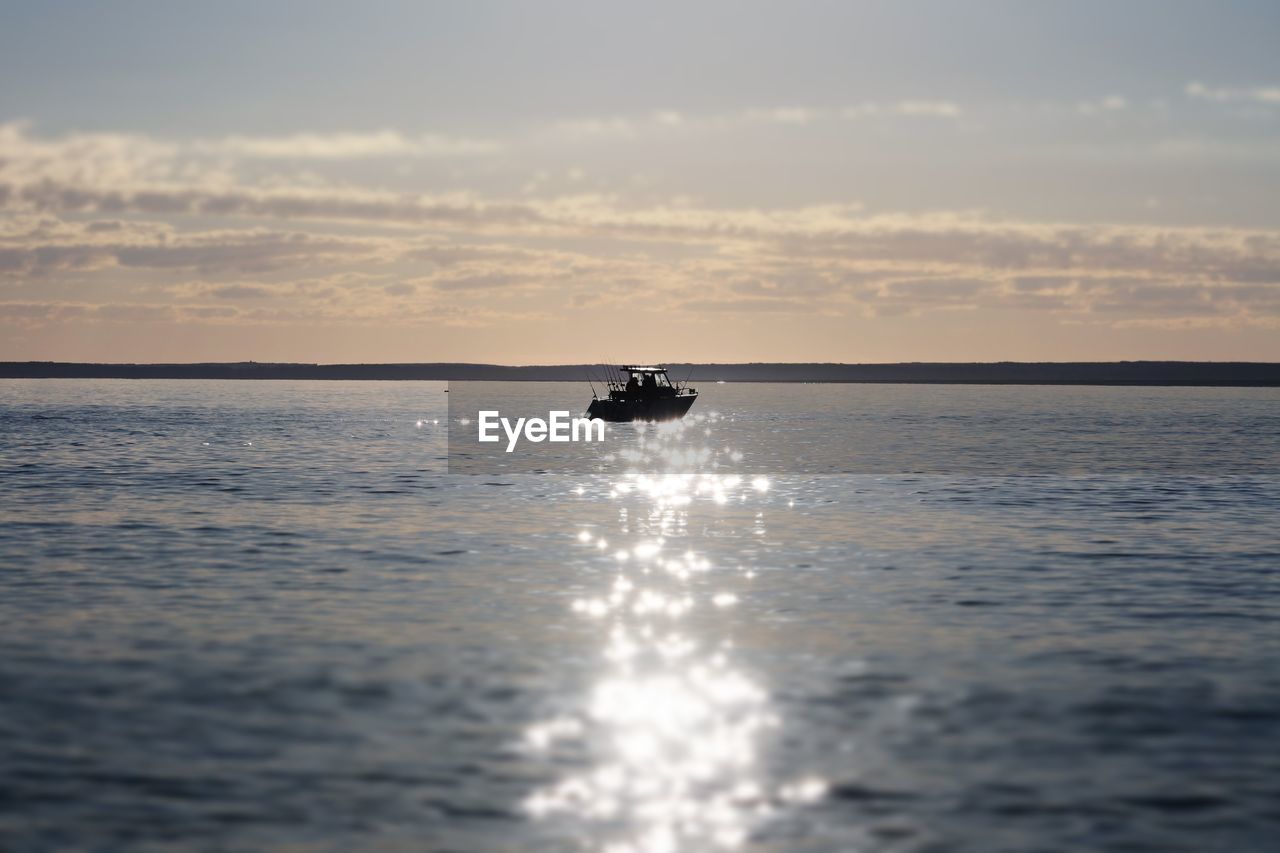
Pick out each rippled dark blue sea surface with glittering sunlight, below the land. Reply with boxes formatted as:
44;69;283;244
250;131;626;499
0;380;1280;853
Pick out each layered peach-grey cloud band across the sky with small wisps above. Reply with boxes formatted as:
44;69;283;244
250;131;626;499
0;119;1280;328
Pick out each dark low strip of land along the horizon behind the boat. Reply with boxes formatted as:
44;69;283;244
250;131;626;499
0;361;1280;387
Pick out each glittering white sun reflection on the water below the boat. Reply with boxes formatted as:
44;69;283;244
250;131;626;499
525;416;826;853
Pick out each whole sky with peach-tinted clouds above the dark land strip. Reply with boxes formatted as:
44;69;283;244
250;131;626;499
0;0;1280;364
